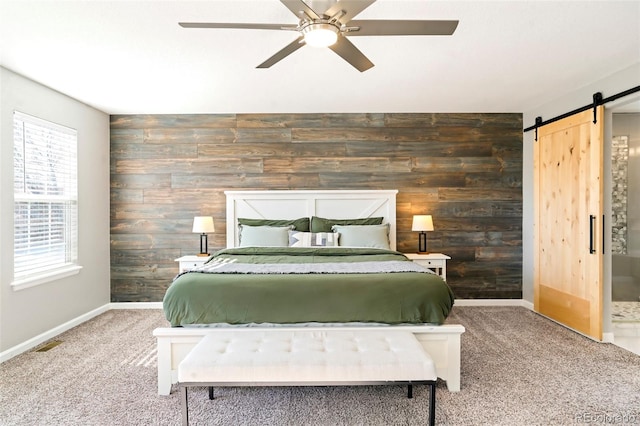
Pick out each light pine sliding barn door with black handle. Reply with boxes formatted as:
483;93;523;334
534;106;604;340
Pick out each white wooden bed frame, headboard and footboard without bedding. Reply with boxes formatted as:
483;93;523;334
153;190;464;395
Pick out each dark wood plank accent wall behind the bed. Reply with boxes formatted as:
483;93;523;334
111;114;522;302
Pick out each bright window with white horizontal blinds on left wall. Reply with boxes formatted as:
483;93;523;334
12;111;80;288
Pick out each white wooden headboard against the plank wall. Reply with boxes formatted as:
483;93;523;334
224;189;398;250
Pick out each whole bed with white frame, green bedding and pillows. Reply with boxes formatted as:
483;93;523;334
154;190;464;395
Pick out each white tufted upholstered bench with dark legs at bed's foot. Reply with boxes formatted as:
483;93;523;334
178;329;437;425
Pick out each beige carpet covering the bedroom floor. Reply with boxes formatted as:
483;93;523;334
0;307;640;426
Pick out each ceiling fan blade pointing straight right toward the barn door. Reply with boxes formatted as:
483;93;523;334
345;20;458;37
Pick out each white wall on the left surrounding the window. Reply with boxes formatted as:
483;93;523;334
0;67;110;353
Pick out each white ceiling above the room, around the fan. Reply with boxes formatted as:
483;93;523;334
0;0;640;114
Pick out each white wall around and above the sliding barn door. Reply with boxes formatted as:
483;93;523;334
522;63;640;332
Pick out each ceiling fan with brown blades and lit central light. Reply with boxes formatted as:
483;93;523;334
179;0;458;72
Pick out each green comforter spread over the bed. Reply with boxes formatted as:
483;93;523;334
163;247;453;326
